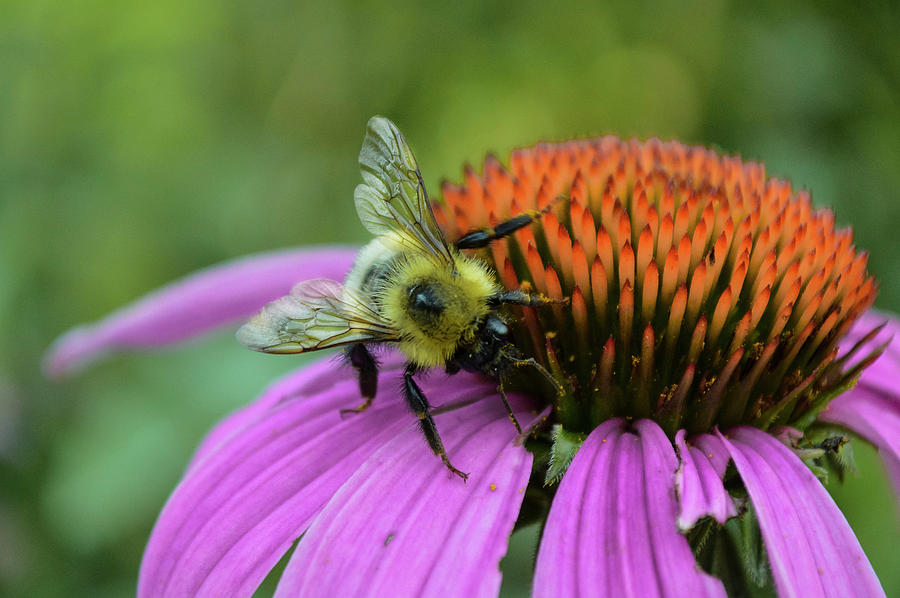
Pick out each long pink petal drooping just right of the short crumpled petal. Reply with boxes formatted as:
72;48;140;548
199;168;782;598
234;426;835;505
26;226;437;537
719;427;884;598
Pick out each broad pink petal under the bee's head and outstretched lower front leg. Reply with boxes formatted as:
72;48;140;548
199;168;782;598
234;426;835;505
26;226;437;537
276;399;532;598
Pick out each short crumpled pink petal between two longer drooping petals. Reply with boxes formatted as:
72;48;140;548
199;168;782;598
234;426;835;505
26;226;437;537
675;430;737;530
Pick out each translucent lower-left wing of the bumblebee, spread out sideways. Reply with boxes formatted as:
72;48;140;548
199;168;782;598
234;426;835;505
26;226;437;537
237;279;399;353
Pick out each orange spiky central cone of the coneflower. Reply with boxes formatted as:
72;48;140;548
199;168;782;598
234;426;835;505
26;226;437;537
435;137;876;434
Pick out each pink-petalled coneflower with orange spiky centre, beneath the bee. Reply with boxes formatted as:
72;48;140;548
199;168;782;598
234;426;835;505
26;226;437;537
47;124;900;596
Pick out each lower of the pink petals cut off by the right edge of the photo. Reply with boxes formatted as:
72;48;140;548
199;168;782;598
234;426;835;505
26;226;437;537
819;390;900;496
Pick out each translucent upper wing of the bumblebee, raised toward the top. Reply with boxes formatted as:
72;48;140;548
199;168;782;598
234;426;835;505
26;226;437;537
353;116;453;263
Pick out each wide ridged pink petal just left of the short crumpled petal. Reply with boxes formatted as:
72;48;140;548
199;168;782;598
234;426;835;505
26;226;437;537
534;419;725;598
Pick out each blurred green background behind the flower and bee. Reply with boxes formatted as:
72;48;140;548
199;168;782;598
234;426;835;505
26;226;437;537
0;0;900;597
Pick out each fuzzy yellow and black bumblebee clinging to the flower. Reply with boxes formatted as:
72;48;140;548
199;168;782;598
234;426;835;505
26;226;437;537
237;116;559;480
